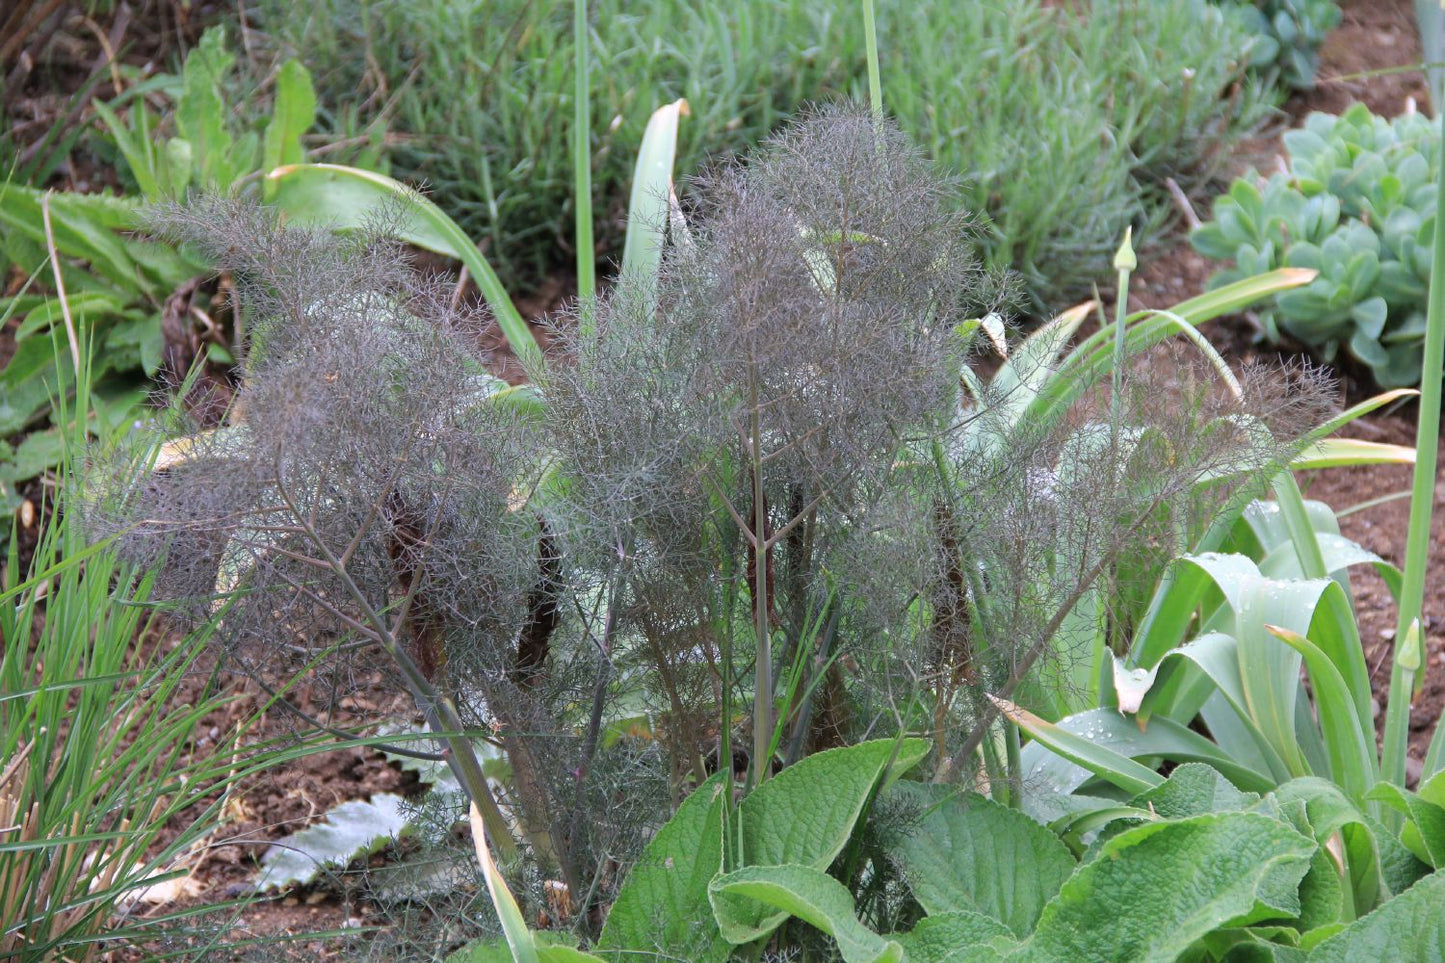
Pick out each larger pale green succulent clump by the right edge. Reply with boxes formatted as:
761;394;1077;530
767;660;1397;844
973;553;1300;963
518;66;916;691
1191;104;1439;388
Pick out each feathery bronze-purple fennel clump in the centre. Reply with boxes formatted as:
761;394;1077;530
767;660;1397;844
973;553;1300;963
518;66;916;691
96;108;1346;959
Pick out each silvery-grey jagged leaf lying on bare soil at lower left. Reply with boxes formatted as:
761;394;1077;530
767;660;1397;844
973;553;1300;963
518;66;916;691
256;792;409;892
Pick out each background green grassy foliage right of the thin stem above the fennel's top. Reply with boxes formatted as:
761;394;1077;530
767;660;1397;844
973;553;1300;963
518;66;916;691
879;0;1274;305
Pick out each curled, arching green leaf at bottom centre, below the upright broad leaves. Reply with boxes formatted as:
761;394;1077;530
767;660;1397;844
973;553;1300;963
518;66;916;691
708;865;903;963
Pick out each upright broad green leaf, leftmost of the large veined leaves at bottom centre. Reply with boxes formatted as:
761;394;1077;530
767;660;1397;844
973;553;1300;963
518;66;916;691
597;774;728;963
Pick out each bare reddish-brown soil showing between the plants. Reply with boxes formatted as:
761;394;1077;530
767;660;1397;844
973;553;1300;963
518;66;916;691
0;0;1445;959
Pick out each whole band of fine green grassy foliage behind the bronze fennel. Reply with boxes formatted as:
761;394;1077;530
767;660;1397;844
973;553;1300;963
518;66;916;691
262;0;1272;314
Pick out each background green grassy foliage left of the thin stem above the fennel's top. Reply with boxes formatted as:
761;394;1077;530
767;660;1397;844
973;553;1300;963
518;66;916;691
259;0;863;283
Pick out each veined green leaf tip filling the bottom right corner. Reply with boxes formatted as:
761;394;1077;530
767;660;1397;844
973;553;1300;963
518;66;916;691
1309;873;1445;963
